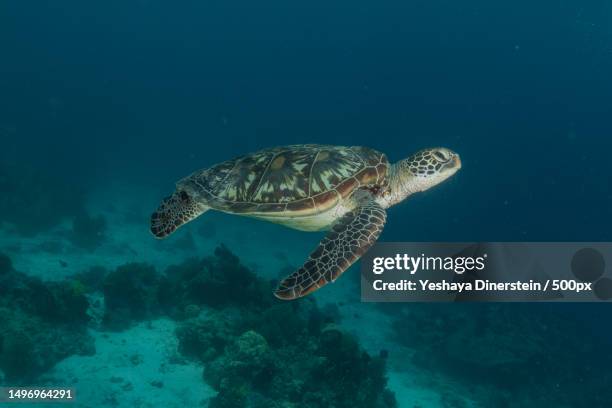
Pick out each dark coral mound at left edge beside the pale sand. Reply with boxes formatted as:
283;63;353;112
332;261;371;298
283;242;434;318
0;254;95;384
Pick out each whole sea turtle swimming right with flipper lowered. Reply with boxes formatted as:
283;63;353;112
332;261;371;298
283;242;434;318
151;144;461;299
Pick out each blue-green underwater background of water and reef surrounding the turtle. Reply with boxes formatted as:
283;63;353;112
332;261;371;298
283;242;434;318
0;0;612;408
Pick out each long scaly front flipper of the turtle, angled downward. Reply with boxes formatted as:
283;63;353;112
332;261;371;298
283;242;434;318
274;200;387;300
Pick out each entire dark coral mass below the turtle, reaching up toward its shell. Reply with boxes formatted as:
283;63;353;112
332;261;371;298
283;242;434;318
171;247;396;408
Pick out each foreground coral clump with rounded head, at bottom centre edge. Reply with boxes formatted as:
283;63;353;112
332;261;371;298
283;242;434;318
197;320;396;408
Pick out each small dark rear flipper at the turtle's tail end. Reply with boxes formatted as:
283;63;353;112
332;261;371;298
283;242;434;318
151;191;208;239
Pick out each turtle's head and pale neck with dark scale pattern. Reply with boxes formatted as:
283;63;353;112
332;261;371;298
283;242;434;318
392;147;461;203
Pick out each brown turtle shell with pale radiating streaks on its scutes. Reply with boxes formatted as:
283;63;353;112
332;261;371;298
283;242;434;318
179;145;389;213
